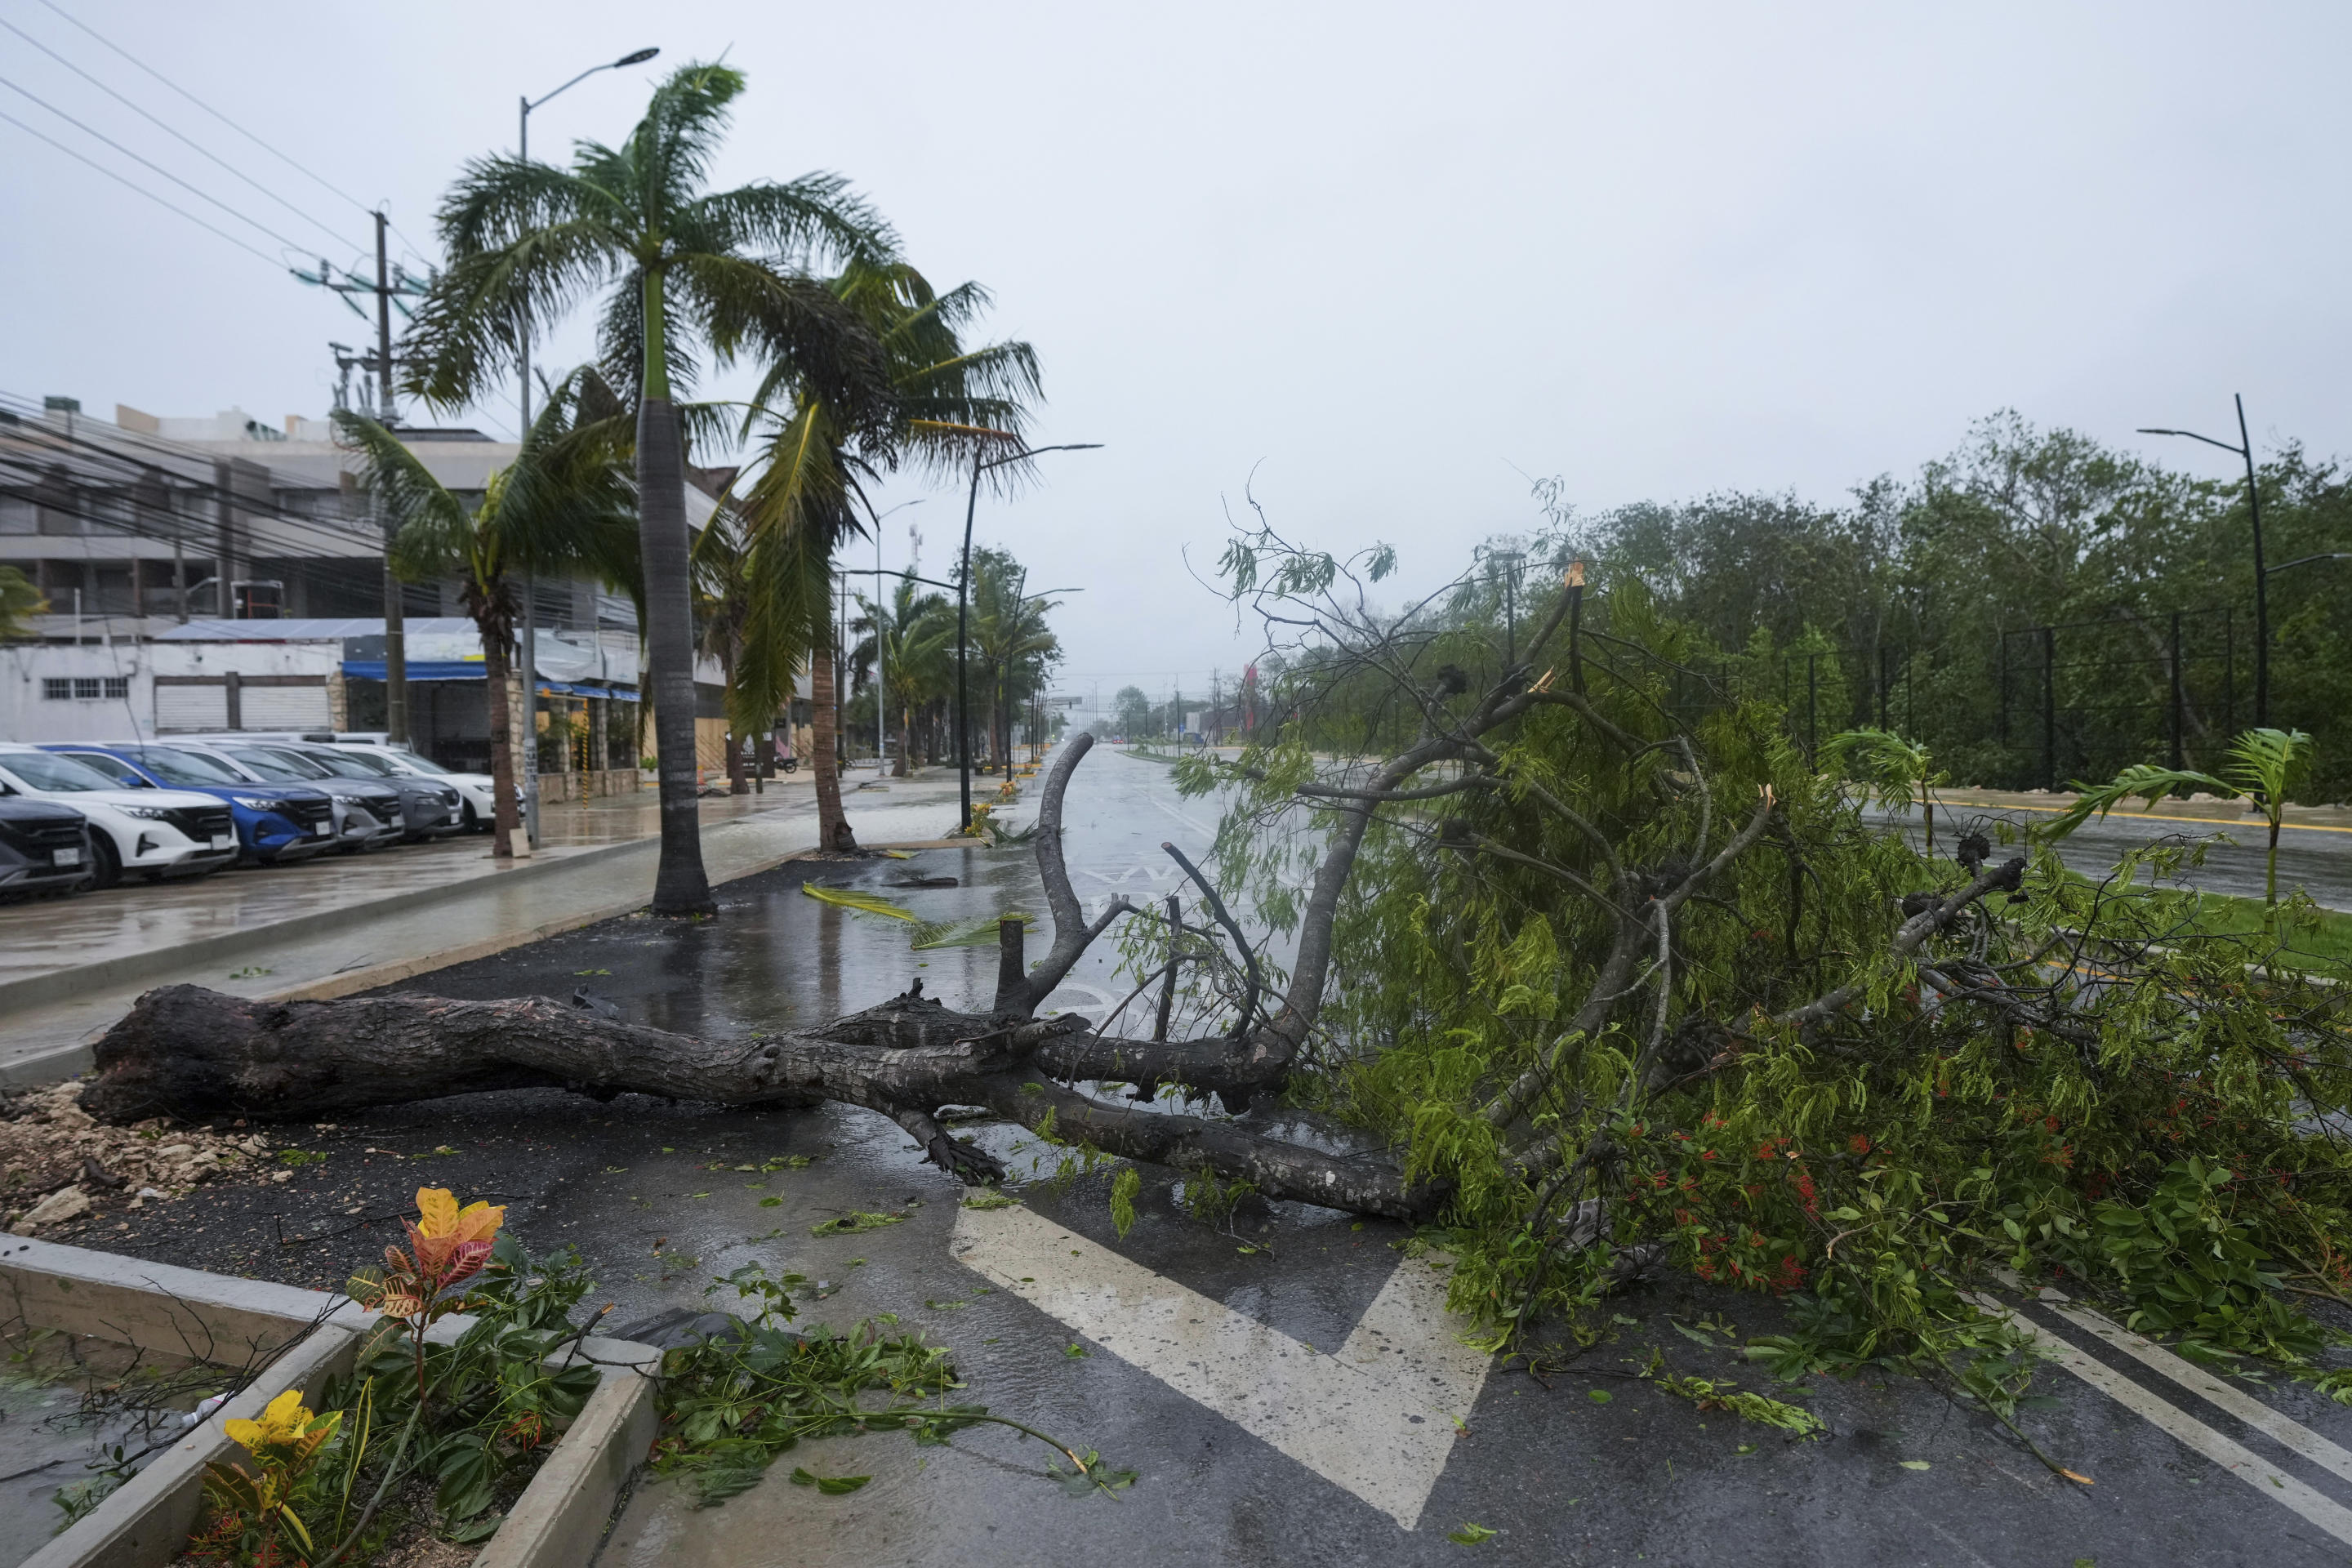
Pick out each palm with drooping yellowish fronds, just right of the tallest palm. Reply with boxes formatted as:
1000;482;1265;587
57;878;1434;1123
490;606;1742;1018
729;259;1040;849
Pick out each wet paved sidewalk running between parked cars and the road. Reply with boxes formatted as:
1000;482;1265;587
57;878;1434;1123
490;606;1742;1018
0;771;957;1084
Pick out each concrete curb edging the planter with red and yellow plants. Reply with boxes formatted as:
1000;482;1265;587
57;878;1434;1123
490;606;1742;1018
0;1236;661;1568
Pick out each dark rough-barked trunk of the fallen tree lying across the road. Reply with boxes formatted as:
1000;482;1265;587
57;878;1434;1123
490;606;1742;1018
82;985;1446;1220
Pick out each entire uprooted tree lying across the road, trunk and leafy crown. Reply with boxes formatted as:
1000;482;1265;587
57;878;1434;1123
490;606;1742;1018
82;510;2352;1365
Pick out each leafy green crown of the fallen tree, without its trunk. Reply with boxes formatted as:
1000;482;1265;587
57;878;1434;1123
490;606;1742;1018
1181;522;2352;1423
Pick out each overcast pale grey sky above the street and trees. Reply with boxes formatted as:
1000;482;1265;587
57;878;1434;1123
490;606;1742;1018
0;0;2352;693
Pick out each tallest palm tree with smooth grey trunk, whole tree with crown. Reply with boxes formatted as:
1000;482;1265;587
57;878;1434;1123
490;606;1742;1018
409;64;892;915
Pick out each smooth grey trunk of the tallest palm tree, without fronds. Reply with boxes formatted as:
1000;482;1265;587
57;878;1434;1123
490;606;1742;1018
637;328;717;915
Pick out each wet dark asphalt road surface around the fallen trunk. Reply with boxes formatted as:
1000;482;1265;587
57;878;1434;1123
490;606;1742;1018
55;755;2352;1568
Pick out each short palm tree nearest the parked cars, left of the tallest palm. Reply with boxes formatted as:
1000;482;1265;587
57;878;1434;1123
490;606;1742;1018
334;372;637;858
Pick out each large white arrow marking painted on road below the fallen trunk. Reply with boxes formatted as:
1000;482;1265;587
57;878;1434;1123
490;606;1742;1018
952;1209;1489;1530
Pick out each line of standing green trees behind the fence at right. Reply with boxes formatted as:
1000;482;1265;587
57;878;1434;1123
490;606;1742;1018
1526;412;2352;800
